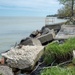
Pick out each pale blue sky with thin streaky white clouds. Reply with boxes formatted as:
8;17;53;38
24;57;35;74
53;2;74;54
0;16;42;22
0;0;61;16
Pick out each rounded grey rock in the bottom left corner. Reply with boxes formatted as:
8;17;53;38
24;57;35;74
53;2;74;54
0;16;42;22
0;66;14;75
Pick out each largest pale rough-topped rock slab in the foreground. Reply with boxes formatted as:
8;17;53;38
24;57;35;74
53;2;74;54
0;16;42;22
2;46;44;70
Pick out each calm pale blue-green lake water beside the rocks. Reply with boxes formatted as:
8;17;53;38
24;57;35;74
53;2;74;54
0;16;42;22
0;17;65;53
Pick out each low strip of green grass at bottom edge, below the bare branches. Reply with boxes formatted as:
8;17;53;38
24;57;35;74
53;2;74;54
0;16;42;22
40;66;75;75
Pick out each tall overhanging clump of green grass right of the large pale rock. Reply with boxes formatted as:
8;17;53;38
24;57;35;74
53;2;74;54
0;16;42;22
44;38;75;64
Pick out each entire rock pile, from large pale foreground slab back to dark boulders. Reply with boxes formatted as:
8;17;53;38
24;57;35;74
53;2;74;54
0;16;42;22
1;22;63;75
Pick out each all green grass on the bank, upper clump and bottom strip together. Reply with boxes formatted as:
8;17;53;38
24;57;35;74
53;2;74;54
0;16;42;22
40;38;75;75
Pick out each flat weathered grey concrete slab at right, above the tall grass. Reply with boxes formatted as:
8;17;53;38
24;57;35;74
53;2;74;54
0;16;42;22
55;25;75;40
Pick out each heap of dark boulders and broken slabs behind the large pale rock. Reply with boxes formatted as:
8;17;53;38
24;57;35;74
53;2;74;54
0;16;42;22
20;26;55;45
